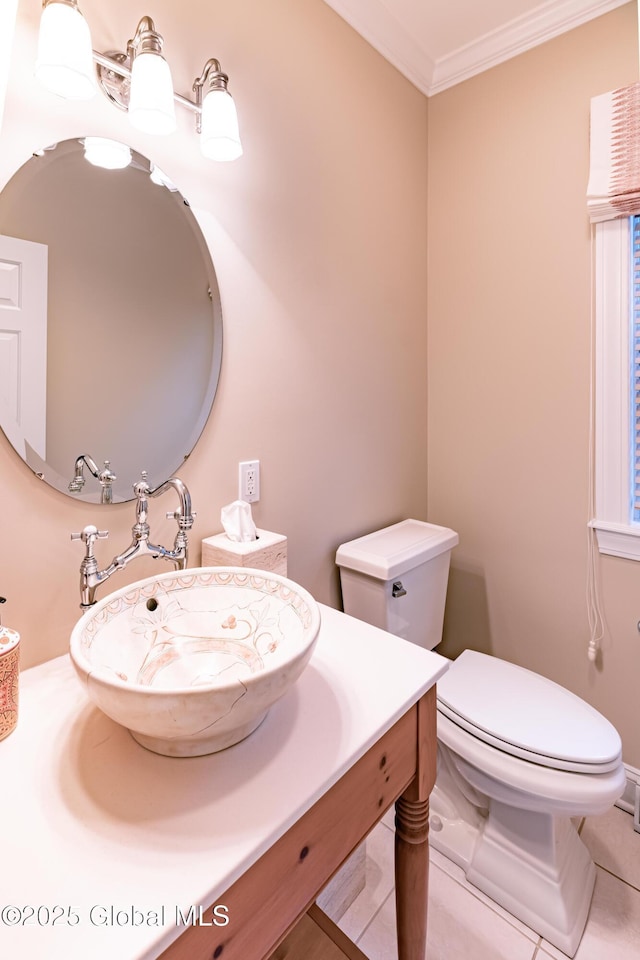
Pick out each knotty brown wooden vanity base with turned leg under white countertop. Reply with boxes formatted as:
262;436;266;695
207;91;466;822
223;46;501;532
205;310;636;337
162;687;436;960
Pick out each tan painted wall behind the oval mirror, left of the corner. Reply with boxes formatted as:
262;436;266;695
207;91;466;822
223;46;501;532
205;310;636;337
0;0;427;666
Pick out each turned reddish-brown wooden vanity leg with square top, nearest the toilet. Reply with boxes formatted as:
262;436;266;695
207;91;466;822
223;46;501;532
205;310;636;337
395;687;437;960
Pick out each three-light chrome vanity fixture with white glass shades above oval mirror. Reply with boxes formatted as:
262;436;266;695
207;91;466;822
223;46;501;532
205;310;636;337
36;0;242;160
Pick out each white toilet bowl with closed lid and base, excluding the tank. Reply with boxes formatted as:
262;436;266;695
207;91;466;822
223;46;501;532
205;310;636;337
430;650;626;956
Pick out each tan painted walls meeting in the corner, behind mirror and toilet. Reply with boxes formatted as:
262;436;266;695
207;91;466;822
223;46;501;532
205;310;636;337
6;0;640;765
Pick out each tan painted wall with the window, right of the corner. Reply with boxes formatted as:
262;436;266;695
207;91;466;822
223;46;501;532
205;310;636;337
428;4;640;766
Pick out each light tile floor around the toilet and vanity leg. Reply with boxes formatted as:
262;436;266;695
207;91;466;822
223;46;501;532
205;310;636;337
332;807;640;960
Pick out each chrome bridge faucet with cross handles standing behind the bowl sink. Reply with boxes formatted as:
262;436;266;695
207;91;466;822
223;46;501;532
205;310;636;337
71;471;195;610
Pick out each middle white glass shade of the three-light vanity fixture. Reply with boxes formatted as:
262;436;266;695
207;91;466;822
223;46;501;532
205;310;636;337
129;53;176;133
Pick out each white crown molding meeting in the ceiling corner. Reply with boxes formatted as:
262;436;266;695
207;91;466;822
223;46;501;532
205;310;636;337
325;0;630;96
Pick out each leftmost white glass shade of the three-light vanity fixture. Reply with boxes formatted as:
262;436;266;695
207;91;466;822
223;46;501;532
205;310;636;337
35;0;98;100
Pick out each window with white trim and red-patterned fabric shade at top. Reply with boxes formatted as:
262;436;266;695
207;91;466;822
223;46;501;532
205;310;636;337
587;83;640;560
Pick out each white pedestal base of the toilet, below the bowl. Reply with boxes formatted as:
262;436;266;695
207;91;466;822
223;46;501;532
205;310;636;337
430;786;596;957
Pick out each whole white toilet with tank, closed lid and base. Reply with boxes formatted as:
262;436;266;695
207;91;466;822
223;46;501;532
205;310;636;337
336;520;625;957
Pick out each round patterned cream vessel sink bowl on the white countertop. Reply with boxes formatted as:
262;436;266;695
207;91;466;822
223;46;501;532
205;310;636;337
70;567;320;757
